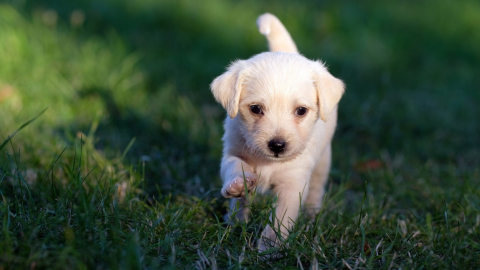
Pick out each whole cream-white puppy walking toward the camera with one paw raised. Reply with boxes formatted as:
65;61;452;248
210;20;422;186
211;13;344;251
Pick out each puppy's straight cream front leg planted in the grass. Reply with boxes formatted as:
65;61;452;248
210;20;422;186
258;171;310;252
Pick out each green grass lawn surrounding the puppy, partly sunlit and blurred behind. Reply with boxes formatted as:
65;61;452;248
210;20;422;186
0;0;480;269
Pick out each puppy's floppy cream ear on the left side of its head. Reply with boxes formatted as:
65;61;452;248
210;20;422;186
210;60;246;118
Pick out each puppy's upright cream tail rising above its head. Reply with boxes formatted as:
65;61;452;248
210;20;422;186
257;13;298;53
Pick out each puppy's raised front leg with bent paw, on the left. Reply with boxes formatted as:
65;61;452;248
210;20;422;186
221;155;258;221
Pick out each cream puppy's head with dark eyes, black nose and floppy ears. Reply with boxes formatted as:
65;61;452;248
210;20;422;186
211;52;344;161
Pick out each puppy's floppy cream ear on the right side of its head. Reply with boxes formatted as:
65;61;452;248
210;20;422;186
313;61;345;121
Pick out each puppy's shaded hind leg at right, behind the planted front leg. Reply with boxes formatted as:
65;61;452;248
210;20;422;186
305;145;332;216
